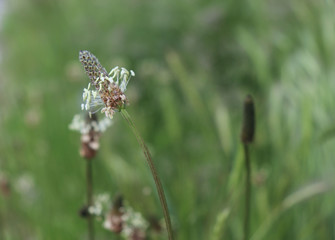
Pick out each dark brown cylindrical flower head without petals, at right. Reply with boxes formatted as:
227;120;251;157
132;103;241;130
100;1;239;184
241;95;255;144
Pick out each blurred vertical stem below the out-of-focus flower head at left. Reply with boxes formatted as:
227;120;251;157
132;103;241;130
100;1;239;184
86;159;94;240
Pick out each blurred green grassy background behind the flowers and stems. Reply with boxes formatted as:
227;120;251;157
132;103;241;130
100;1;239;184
0;0;335;240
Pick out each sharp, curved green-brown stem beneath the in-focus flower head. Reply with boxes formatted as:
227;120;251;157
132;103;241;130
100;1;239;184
121;109;173;240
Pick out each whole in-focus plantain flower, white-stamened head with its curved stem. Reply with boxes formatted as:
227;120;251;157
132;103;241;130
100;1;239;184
79;50;173;240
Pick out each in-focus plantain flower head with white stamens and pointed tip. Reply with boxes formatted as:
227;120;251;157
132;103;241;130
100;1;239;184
79;50;135;119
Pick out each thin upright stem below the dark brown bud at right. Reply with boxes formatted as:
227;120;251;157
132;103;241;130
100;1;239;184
243;143;251;240
